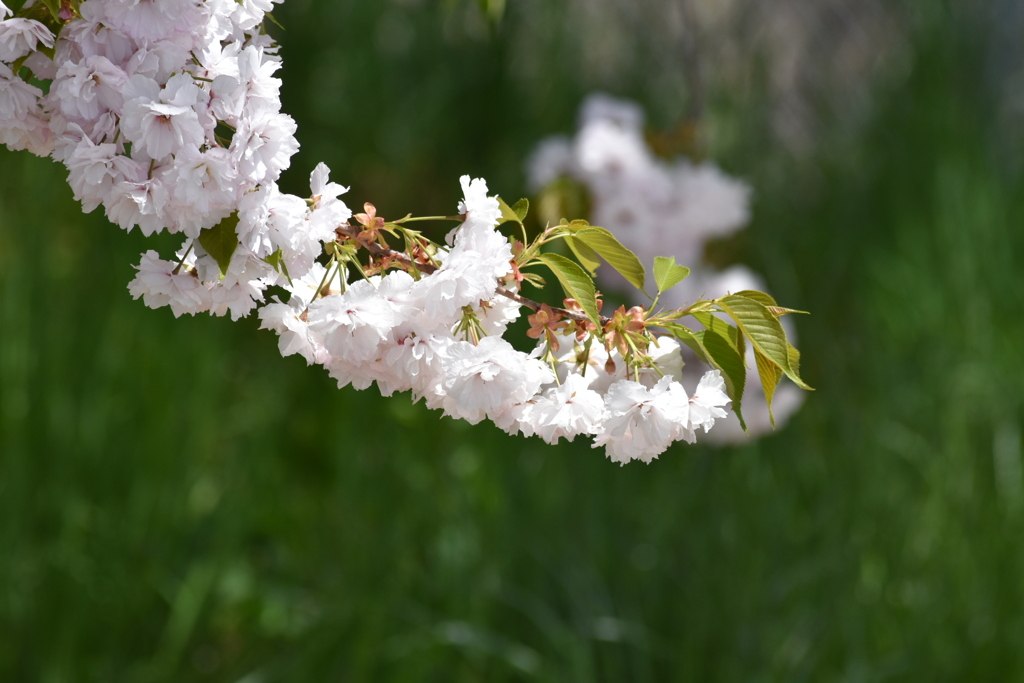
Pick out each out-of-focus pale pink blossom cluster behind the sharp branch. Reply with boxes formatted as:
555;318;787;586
526;93;803;441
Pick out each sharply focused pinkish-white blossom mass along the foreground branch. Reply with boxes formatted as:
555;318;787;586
0;0;806;463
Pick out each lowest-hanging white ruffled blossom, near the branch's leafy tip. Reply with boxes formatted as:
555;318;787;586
594;377;692;465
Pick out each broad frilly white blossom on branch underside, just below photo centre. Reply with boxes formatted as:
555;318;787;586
443;337;554;424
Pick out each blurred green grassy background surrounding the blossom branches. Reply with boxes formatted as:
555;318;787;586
0;0;1024;683
